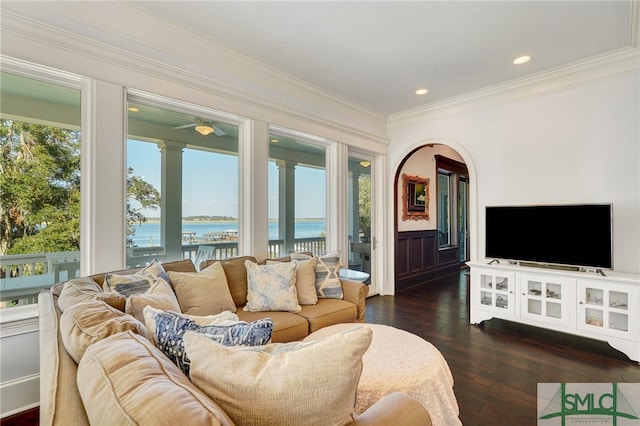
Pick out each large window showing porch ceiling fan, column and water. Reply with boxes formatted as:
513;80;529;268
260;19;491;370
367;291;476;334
127;95;240;267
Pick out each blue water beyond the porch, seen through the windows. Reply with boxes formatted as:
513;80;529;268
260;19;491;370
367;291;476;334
133;220;327;247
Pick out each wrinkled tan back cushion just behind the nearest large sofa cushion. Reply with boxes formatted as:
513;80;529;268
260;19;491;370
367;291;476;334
60;300;151;363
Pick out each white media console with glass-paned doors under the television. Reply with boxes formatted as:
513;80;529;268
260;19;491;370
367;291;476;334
467;260;640;362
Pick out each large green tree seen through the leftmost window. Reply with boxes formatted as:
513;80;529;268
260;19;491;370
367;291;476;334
0;118;80;254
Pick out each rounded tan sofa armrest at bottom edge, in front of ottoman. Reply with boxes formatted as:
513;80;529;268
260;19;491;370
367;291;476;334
349;392;431;426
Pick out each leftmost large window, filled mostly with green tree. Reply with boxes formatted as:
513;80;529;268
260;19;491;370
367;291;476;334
0;72;81;308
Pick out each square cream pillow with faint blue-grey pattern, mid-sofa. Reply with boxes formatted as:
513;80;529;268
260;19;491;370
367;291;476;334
244;260;302;313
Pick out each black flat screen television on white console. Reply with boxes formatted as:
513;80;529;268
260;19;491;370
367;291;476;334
485;204;613;269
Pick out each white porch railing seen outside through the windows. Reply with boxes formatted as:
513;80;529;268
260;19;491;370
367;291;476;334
0;237;325;308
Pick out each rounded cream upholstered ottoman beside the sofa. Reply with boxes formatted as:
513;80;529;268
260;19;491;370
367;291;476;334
305;324;462;426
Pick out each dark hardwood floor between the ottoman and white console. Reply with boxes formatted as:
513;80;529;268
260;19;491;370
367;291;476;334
366;271;640;426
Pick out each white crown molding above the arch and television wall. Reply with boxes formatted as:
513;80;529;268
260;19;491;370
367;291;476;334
387;47;640;129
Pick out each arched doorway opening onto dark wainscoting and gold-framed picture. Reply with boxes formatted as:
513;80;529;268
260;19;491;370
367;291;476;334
394;143;471;291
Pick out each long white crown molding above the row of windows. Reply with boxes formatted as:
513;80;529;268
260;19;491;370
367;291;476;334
2;2;387;151
